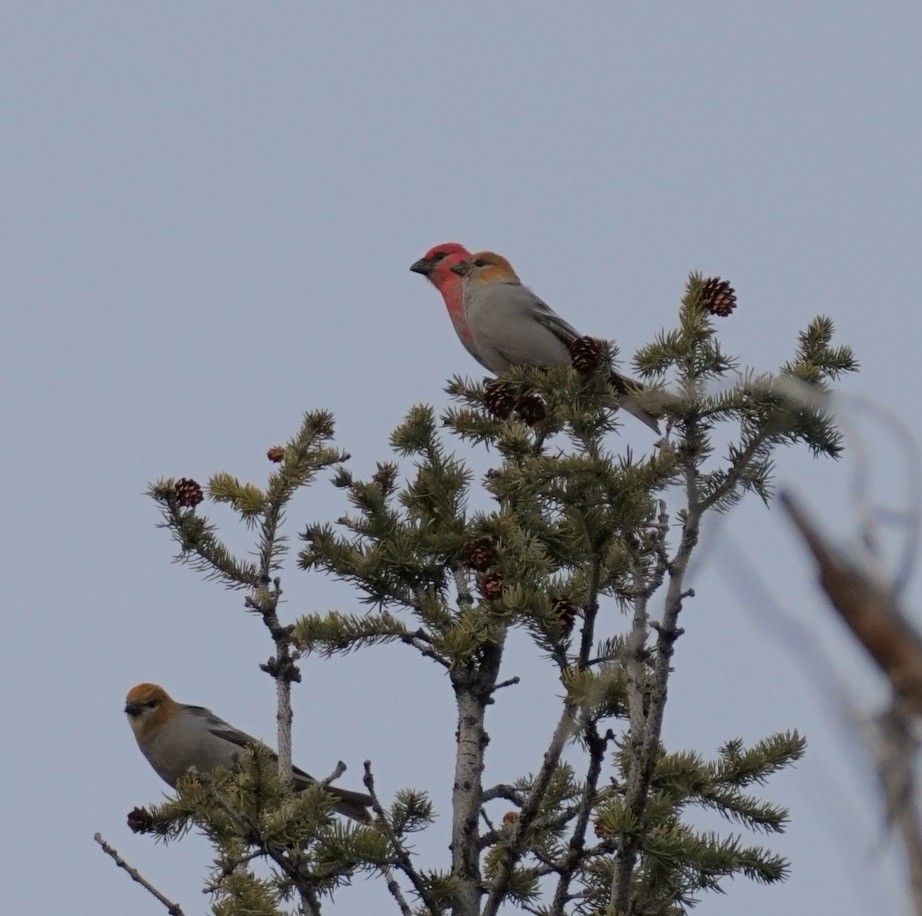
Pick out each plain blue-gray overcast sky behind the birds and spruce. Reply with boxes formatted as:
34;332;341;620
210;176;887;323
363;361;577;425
0;0;922;916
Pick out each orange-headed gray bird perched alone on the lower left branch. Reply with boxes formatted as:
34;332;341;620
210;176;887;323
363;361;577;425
125;684;371;821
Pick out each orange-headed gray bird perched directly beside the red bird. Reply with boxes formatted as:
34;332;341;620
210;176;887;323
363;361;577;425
449;251;659;432
